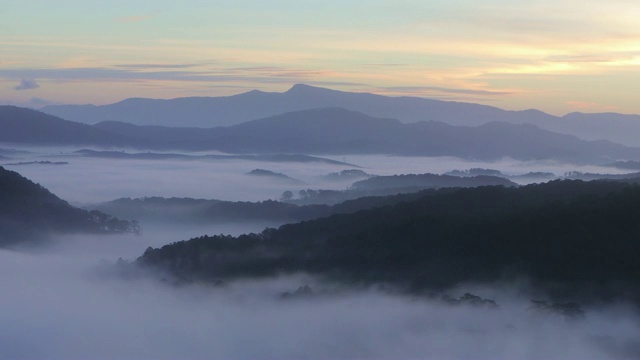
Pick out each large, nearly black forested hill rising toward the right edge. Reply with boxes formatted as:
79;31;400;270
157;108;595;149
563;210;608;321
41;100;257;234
137;181;640;301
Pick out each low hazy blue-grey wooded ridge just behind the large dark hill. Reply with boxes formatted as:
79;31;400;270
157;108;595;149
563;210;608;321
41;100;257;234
87;174;517;223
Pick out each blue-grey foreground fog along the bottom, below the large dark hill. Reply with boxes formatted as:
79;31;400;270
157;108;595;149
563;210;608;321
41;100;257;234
0;232;640;360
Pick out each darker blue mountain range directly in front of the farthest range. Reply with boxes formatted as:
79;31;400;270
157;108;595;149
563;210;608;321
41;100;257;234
0;106;640;163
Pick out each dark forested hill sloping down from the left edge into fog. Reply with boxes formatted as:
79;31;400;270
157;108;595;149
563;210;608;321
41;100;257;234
0;167;140;246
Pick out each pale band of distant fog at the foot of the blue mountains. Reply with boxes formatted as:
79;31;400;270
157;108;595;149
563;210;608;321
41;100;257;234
0;148;629;204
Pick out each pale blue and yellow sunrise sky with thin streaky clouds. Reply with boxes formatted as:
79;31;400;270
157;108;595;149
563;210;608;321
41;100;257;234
0;0;640;115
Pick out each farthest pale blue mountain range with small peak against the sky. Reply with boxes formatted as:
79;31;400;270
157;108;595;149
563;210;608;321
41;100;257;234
42;84;640;146
